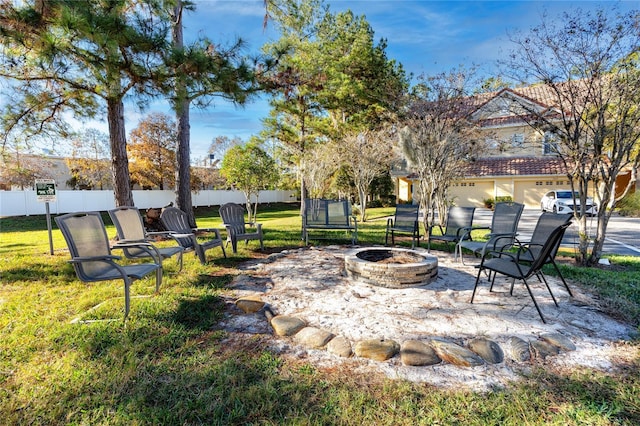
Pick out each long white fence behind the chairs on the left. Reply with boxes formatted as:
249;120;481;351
0;190;296;217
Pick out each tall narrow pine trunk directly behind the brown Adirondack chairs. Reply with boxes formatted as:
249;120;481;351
172;0;196;228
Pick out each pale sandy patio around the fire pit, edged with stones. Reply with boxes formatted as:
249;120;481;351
223;246;638;390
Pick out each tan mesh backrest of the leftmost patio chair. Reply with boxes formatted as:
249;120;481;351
55;212;113;281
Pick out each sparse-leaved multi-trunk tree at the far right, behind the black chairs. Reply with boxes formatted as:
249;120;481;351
503;8;640;265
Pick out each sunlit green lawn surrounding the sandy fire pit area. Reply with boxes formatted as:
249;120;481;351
0;205;640;425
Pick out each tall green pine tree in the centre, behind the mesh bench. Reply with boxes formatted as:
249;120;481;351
264;0;408;208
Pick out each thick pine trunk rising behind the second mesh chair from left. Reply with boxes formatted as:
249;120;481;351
107;98;134;207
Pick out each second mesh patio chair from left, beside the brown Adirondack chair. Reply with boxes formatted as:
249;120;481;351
109;207;184;271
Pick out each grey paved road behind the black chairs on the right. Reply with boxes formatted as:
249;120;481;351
473;209;640;256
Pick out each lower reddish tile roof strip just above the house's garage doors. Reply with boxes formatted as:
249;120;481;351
464;156;567;177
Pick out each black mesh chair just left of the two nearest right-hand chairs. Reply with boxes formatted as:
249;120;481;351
456;203;524;264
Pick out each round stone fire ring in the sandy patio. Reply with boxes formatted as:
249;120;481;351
344;247;438;288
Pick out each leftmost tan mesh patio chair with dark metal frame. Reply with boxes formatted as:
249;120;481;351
55;212;162;320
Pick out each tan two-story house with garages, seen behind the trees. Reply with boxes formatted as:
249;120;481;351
392;85;630;208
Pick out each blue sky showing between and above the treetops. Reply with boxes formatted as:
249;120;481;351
138;0;640;161
